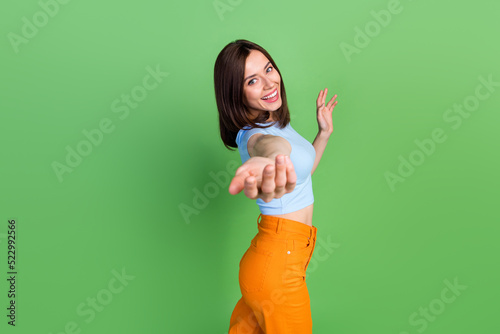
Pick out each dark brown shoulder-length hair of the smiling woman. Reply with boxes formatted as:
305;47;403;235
214;39;290;150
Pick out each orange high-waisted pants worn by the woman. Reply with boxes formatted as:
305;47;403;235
229;214;316;334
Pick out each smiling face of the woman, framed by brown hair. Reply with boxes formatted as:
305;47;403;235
243;50;282;119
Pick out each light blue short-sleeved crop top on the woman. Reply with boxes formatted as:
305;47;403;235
236;123;316;215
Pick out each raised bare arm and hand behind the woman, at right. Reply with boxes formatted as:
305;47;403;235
311;88;338;175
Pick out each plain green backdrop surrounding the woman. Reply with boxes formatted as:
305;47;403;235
0;0;500;334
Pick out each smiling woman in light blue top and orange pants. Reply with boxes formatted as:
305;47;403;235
214;40;337;334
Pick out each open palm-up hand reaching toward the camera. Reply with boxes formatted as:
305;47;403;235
229;154;297;203
